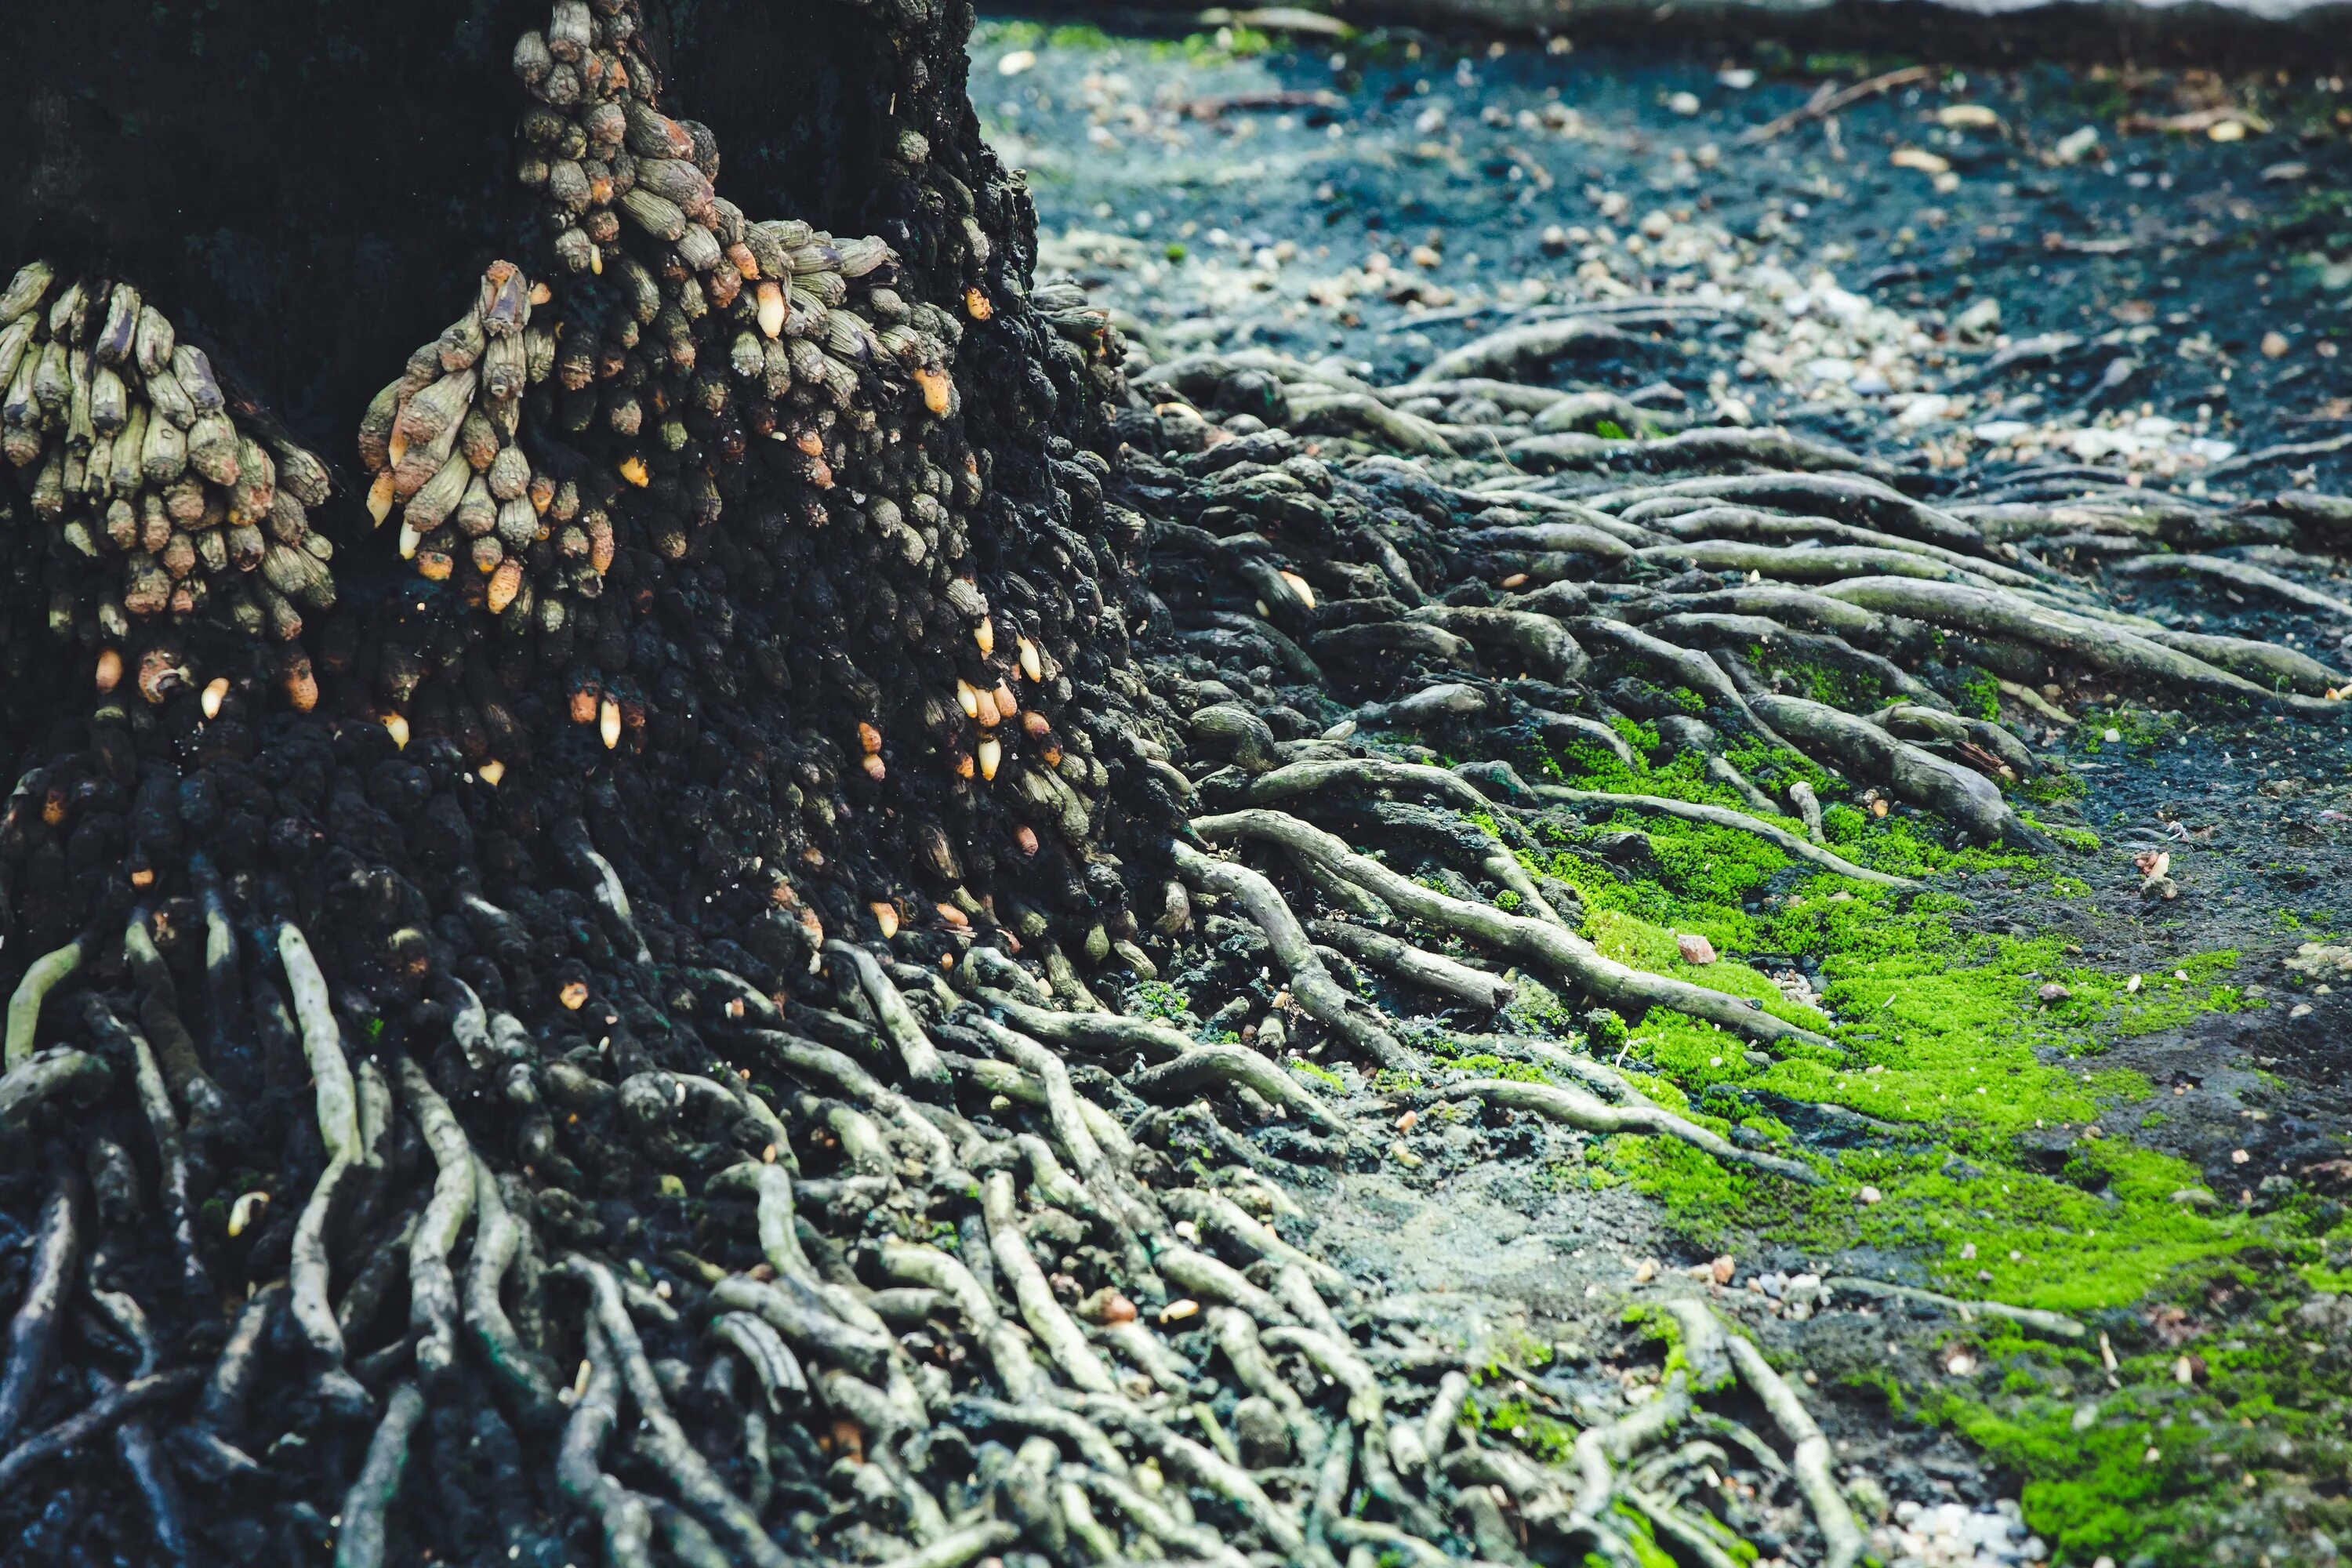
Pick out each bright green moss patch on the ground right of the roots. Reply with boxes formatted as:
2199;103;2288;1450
1463;720;2352;1563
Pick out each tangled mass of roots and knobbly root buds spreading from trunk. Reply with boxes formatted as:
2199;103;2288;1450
0;0;2352;1568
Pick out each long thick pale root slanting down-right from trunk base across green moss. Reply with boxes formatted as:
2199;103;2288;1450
1192;811;1830;1046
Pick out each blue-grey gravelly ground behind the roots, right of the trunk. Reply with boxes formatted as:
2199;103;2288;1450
974;24;2352;487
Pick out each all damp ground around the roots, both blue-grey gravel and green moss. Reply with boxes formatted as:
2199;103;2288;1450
974;21;2352;1563
